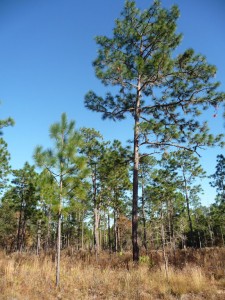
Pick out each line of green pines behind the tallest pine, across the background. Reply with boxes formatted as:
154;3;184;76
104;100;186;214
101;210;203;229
0;114;225;253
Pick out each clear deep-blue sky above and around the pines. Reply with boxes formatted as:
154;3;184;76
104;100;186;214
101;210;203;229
0;0;225;204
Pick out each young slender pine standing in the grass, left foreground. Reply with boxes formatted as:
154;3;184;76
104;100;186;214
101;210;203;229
34;113;87;286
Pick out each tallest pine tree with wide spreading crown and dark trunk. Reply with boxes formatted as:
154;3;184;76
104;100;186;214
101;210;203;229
85;0;225;261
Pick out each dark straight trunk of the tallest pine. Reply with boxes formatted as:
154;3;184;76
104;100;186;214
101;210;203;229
132;76;141;262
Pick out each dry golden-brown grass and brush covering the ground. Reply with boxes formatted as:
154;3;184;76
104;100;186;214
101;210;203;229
0;248;225;300
